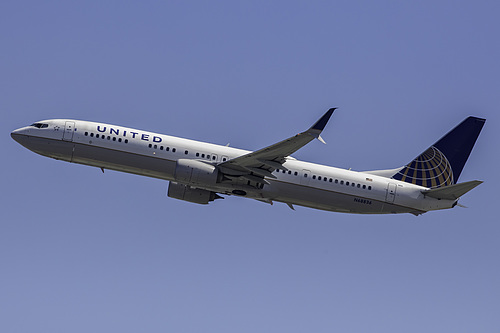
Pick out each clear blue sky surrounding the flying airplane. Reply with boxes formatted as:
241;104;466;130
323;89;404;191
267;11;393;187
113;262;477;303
0;1;500;333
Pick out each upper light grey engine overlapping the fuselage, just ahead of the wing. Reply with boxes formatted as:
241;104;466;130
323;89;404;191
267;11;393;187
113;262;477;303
174;159;219;185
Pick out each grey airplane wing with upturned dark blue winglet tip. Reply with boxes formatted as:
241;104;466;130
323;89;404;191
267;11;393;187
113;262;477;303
218;108;336;184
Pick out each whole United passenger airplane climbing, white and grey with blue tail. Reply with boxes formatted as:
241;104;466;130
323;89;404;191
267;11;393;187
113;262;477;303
11;108;486;215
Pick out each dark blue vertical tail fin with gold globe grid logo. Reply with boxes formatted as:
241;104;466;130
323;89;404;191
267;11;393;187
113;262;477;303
392;117;486;188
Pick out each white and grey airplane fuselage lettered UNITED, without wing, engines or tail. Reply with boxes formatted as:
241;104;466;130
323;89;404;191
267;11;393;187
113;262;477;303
12;119;456;214
